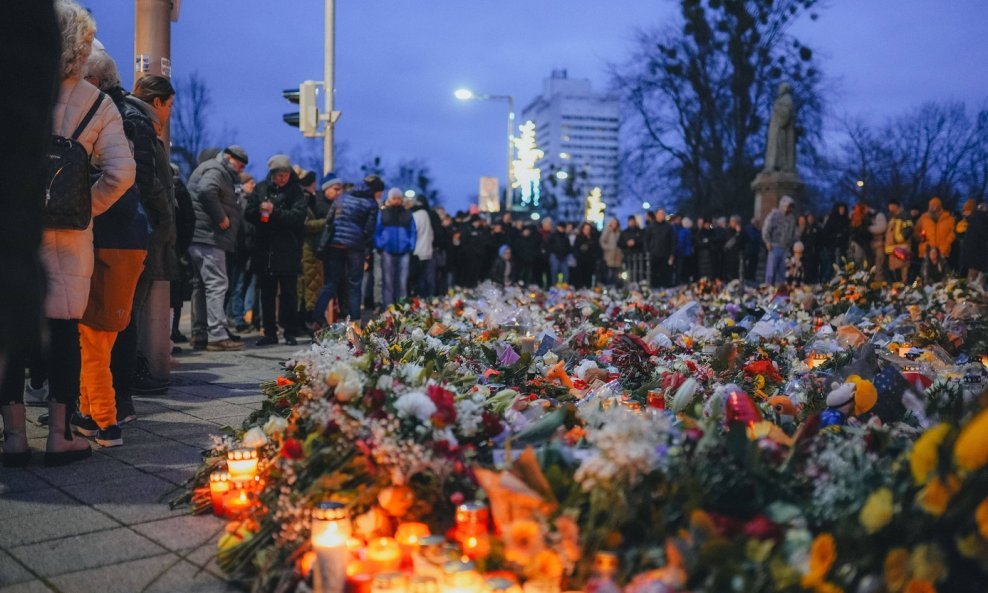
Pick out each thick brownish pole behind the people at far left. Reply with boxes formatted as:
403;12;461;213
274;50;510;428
134;0;172;379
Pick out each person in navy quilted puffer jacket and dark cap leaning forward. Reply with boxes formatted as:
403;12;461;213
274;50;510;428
315;175;384;325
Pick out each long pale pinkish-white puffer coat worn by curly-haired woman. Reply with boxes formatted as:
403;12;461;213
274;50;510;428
41;78;135;319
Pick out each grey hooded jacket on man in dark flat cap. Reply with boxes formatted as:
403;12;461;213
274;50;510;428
187;152;242;252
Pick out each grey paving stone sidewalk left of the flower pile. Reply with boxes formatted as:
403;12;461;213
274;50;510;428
0;335;307;593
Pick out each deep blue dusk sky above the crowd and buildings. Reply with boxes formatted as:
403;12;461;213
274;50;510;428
80;0;988;209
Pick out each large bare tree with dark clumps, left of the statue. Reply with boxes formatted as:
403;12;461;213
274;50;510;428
613;0;822;214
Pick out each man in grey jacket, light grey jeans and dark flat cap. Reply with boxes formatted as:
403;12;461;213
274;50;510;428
188;145;248;351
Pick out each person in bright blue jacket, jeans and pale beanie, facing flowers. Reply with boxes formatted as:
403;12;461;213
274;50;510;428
374;191;418;308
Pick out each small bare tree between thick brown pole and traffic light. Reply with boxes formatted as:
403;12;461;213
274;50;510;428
171;72;218;178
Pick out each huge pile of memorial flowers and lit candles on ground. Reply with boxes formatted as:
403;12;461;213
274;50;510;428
183;269;988;593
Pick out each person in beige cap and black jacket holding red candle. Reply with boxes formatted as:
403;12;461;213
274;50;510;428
244;154;306;346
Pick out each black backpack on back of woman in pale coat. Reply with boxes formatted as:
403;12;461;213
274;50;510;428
44;93;105;231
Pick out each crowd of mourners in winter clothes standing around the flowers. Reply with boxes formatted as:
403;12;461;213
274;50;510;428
0;0;988;466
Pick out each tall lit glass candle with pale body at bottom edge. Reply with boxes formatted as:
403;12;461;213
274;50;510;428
311;502;351;593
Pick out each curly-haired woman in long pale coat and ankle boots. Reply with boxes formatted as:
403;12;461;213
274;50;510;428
0;0;135;466
